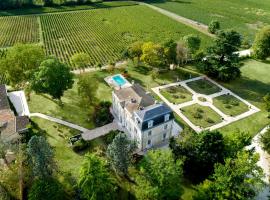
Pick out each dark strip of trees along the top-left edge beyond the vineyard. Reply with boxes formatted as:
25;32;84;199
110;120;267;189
0;0;102;10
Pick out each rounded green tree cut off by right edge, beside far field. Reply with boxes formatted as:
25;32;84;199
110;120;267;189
253;26;270;60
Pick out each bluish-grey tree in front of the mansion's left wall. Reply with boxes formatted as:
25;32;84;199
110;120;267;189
107;133;136;175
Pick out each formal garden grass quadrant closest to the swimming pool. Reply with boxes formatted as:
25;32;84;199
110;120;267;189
160;86;192;104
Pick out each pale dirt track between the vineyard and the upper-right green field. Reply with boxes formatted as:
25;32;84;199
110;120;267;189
138;2;215;37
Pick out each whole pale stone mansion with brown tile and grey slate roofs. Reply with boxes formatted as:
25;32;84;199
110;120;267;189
112;84;174;151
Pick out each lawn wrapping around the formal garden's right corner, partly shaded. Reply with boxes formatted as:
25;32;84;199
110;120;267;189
220;60;270;136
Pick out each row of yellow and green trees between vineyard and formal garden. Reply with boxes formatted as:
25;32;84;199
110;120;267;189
123;35;201;68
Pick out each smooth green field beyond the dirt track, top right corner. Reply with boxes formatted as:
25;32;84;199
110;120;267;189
150;0;270;40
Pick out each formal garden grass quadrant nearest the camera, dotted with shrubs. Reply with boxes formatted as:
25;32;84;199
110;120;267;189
182;104;222;128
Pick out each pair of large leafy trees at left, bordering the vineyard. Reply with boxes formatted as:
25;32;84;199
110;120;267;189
0;44;74;103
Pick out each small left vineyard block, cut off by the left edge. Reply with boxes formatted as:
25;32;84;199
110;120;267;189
0;16;39;48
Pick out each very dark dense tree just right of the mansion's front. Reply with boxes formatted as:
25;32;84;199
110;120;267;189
170;131;226;182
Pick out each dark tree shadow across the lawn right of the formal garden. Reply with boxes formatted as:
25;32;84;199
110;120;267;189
223;77;270;103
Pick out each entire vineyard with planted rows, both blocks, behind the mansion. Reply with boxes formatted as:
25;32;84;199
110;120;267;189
0;4;210;67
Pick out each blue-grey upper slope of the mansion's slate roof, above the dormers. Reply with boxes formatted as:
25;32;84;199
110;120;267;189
136;103;172;122
